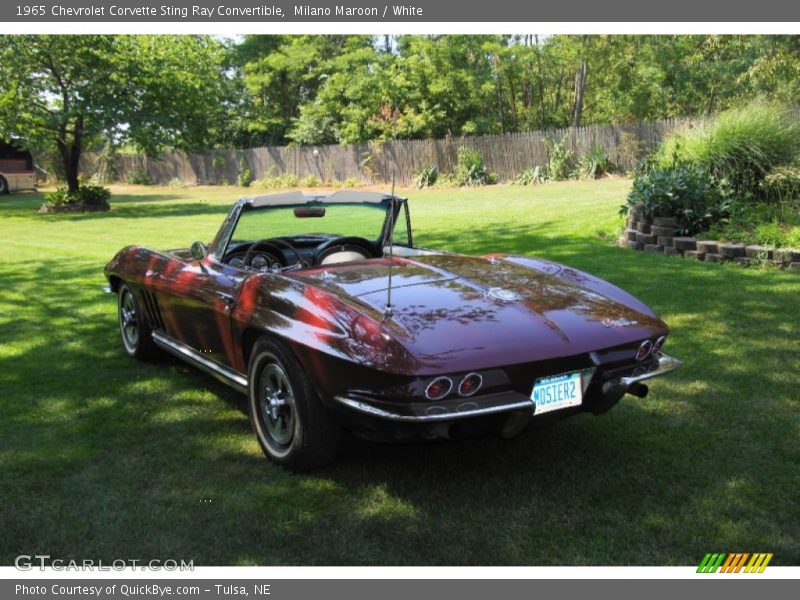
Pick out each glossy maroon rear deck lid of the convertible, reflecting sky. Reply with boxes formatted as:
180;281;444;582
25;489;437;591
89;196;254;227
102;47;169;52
296;254;667;370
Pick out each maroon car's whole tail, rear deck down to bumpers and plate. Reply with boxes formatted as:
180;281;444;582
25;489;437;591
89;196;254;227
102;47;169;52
282;255;680;440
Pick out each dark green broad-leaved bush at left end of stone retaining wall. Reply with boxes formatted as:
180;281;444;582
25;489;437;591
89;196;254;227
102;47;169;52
620;162;730;235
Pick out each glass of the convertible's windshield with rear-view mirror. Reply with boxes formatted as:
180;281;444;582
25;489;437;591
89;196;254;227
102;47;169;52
231;202;387;243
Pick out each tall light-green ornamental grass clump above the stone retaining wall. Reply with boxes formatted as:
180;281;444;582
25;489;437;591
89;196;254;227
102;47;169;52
656;101;800;198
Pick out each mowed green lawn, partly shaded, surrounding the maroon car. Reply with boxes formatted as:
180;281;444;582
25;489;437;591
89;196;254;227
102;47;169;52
0;179;800;565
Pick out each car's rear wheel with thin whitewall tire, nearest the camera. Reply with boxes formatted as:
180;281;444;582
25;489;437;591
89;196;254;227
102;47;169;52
248;337;341;471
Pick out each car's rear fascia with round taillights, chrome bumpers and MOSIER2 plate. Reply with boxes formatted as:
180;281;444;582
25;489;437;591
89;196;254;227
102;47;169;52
324;339;681;440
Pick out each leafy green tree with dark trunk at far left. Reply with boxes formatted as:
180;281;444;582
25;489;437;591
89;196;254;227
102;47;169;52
0;35;229;192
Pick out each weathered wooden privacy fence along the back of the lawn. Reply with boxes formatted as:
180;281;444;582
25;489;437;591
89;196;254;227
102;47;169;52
81;119;696;185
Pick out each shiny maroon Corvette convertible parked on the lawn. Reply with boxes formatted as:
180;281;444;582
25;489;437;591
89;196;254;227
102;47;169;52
105;191;680;470
